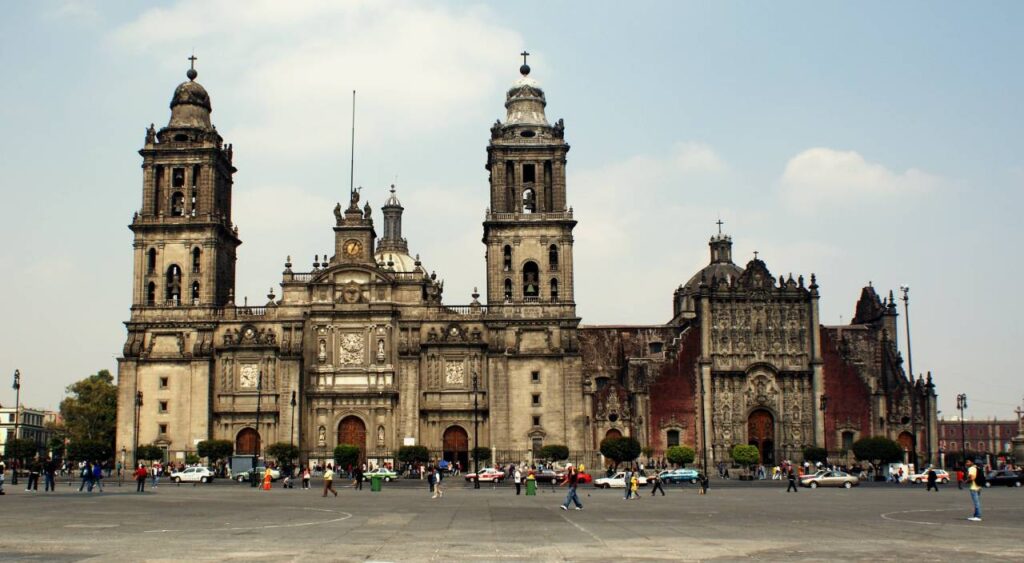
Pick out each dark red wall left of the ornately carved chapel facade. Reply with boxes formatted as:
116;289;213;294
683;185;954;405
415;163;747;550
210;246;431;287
648;327;700;452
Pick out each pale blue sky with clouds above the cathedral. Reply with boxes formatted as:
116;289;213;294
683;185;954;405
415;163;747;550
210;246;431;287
0;0;1024;418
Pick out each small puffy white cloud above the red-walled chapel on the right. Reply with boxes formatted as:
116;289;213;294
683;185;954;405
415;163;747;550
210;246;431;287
780;147;941;212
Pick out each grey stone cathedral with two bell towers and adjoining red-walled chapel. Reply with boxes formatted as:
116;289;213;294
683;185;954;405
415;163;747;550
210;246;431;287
117;57;938;472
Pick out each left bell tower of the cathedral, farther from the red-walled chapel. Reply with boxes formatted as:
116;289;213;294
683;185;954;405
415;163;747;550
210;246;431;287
130;55;242;308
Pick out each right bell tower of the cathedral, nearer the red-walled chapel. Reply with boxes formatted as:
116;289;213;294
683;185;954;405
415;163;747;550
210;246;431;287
483;51;575;307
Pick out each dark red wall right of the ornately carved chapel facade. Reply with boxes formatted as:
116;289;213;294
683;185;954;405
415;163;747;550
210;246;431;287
821;327;871;450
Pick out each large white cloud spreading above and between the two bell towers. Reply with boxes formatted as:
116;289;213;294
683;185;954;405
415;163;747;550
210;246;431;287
113;0;522;163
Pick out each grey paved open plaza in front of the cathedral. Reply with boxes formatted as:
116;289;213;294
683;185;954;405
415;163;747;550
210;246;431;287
0;481;1024;561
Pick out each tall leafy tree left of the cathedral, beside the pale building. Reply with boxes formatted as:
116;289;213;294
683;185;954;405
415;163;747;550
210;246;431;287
60;370;118;460
